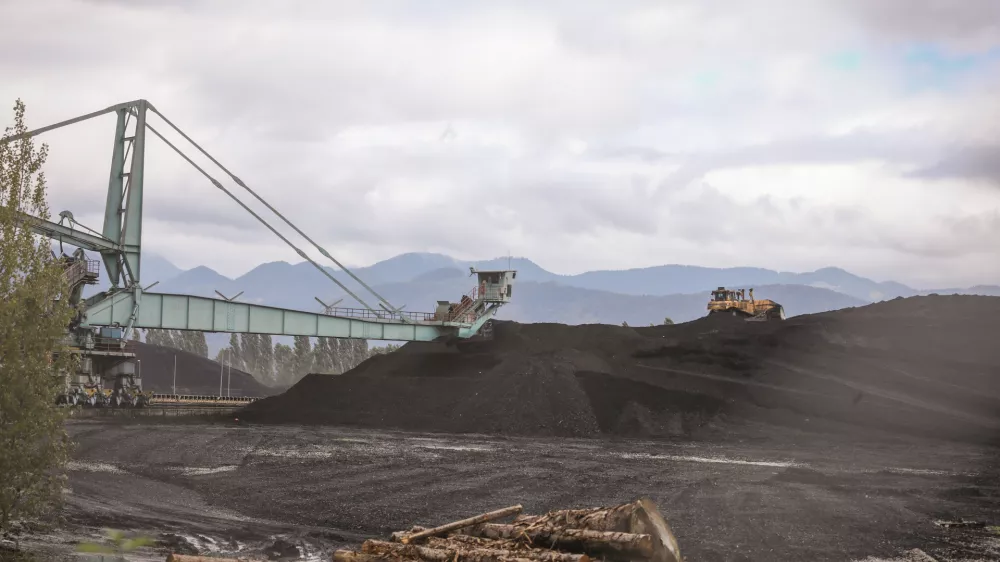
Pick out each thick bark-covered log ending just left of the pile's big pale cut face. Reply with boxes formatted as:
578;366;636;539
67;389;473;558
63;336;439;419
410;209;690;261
458;523;655;560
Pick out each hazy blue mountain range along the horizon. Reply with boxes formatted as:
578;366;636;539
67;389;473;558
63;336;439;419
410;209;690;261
72;249;1000;353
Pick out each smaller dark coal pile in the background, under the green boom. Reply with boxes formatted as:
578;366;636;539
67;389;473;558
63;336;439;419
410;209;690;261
133;342;274;397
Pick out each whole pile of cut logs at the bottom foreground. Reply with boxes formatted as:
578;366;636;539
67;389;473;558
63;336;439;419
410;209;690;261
333;499;681;562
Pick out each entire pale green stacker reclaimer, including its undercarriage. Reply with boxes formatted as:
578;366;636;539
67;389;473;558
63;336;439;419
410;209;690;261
0;100;517;407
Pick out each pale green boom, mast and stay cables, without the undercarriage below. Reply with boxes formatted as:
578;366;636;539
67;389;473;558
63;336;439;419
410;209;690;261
0;100;516;341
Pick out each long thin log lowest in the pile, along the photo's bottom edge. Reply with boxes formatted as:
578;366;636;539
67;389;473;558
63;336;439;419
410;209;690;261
361;539;590;562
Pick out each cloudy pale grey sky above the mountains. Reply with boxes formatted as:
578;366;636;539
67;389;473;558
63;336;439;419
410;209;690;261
0;0;1000;288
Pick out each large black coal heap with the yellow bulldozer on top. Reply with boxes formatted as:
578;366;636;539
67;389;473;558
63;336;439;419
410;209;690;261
242;296;1000;441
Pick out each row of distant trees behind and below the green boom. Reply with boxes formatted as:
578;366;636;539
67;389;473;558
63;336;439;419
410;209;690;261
134;330;399;386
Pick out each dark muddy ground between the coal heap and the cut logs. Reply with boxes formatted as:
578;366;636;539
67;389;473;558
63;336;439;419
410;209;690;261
17;420;1000;561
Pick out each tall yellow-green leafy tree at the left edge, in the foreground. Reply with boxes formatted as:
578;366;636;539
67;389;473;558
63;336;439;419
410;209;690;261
0;100;74;533
